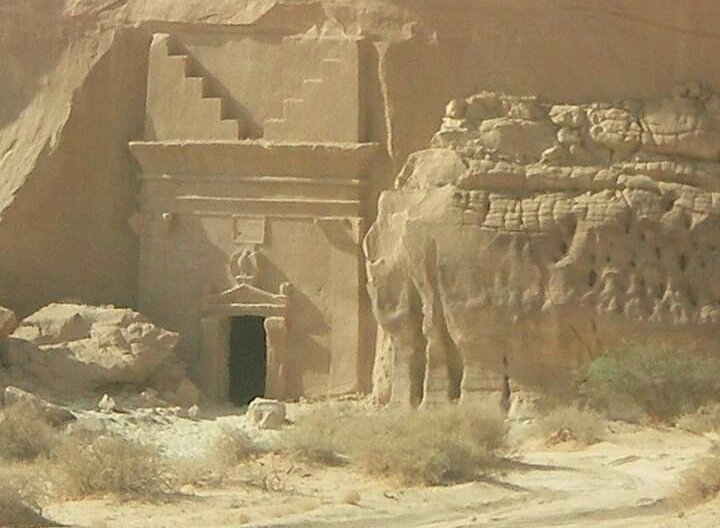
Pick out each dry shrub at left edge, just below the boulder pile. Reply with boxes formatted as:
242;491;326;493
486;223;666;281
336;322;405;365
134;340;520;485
0;405;59;461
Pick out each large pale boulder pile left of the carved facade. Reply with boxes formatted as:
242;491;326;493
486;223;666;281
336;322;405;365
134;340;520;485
1;304;195;405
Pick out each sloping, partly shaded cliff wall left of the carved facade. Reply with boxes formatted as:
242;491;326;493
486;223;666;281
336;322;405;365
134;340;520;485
0;2;144;313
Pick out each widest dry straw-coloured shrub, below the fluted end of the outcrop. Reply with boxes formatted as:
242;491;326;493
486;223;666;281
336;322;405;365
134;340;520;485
286;405;506;485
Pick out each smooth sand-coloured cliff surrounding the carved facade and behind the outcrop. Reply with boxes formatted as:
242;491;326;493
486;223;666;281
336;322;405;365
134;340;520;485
0;0;720;313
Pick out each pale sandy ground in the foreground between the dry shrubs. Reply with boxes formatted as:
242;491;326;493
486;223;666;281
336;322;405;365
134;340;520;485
45;406;720;528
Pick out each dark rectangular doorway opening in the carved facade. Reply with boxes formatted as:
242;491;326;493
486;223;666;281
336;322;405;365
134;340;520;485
228;315;267;405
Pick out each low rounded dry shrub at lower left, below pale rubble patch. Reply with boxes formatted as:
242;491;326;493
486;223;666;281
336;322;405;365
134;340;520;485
53;436;173;499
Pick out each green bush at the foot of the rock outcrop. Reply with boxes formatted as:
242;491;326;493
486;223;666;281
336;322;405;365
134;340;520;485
583;343;720;423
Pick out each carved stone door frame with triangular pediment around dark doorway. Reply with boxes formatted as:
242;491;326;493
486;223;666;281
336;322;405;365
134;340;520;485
202;283;291;402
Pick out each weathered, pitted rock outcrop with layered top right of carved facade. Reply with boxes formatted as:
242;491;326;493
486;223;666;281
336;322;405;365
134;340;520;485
365;84;720;404
